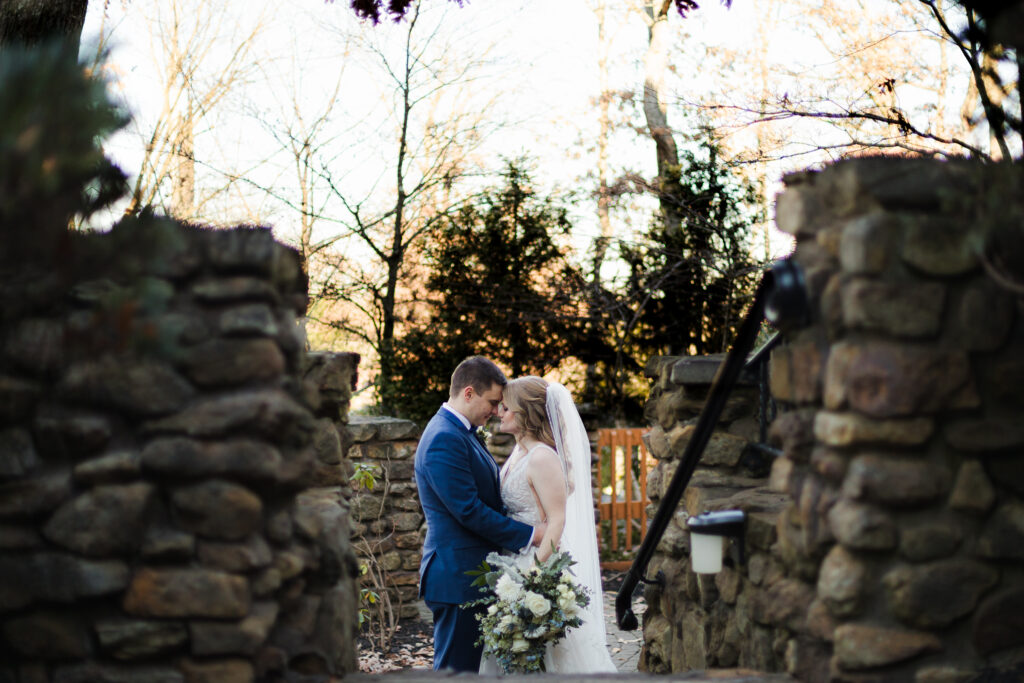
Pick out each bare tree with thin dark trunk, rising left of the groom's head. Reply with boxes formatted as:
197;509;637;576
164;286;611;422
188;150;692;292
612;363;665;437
234;2;500;409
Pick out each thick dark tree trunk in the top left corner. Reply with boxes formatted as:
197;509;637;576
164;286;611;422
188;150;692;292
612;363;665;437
0;0;89;53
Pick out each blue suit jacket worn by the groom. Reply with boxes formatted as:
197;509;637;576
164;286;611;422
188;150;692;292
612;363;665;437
416;408;532;603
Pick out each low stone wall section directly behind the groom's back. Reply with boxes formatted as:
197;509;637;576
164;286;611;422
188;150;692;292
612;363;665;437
347;417;426;618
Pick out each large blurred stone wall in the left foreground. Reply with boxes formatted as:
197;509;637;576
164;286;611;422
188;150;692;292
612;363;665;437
0;219;356;683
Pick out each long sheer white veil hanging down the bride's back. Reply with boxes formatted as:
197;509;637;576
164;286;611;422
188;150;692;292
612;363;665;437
546;382;615;672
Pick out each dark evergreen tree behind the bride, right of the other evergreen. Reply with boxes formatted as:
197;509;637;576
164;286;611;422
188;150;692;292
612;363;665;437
581;131;761;422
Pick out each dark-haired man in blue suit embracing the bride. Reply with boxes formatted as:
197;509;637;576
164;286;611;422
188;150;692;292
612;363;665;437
416;355;544;673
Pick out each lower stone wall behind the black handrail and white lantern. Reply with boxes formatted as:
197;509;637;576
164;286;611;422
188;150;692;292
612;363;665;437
639;356;786;673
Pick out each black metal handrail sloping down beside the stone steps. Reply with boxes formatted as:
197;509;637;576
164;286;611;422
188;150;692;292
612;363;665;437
615;259;808;631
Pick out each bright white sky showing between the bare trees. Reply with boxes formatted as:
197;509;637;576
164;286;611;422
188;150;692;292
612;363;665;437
77;0;1007;401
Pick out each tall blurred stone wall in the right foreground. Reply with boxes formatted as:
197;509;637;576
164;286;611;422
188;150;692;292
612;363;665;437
645;159;1024;683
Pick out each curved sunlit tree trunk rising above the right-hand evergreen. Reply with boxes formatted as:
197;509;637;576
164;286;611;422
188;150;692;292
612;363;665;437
643;0;681;234
